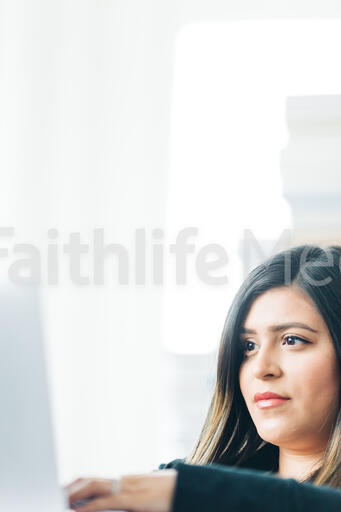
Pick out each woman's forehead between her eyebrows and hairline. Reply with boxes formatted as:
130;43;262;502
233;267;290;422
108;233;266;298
243;286;326;329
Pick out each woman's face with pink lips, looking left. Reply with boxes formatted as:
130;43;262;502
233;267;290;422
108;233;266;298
239;286;339;450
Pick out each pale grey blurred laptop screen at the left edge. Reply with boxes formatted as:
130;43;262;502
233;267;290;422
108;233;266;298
0;277;68;512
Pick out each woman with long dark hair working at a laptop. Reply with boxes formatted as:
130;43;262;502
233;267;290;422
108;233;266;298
68;245;341;512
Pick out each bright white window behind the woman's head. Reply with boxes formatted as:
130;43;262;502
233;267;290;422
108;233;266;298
164;20;341;353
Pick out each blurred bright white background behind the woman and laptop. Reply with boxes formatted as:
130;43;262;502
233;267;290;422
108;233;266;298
0;0;341;481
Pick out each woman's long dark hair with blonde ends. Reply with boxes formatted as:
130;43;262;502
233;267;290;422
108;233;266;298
186;245;341;487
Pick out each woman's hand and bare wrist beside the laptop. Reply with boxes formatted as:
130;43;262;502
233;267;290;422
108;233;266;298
66;469;177;512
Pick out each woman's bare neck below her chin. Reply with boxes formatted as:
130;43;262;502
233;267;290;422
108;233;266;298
278;448;325;482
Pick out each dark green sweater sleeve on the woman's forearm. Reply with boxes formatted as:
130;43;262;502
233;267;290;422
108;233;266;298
166;461;341;512
